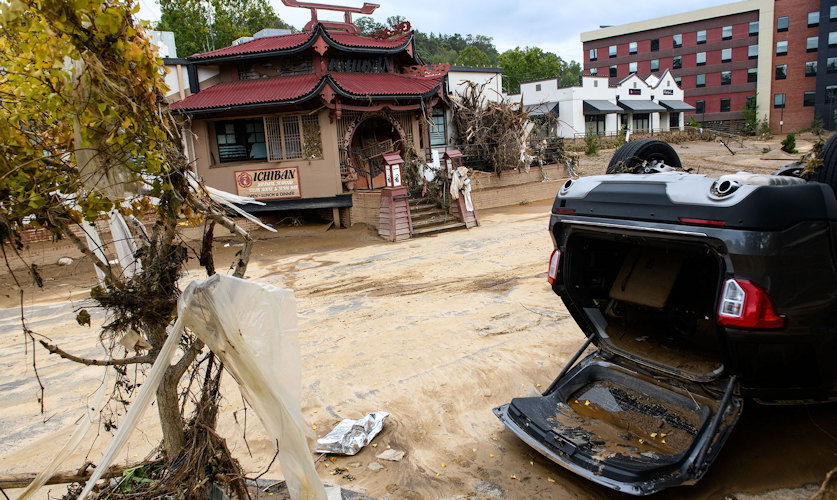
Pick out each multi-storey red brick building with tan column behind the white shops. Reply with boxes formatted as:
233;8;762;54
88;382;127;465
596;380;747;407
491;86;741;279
581;0;837;132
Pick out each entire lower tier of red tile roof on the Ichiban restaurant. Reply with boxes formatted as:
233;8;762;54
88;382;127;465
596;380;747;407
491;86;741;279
171;73;443;112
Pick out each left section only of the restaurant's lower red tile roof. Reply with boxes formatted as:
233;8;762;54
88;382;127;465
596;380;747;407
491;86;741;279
171;74;320;111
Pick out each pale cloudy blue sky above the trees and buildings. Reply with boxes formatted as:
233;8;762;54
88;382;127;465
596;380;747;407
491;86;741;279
140;0;730;61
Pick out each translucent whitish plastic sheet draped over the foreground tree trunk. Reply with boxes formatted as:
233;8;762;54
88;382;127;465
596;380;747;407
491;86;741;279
79;274;326;500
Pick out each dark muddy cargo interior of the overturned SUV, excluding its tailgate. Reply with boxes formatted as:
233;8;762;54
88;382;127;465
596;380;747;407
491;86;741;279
564;233;724;382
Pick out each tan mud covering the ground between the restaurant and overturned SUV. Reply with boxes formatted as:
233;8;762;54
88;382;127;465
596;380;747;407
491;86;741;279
0;135;837;498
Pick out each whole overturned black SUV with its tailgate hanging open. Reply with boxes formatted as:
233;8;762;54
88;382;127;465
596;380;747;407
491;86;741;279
494;136;837;495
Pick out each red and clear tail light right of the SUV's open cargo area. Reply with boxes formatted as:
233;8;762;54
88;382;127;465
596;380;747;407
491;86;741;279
718;278;785;330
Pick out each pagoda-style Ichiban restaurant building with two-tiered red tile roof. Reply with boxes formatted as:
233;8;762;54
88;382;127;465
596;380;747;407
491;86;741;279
167;0;449;225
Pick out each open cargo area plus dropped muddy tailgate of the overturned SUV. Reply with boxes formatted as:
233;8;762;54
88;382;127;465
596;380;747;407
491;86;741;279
495;231;741;495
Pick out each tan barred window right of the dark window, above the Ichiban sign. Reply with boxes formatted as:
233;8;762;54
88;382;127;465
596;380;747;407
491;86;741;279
264;114;323;161
